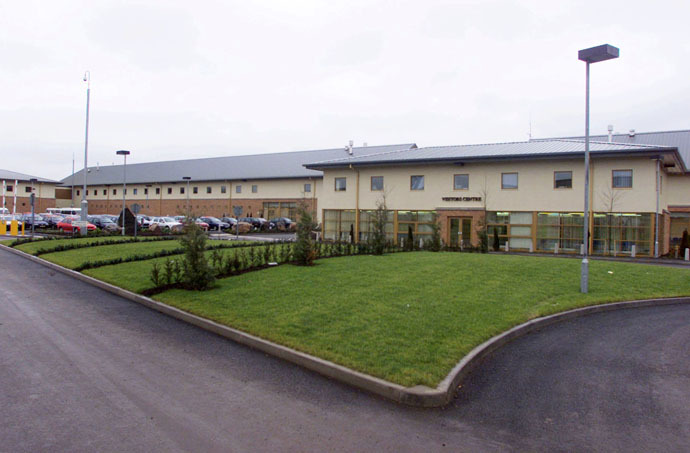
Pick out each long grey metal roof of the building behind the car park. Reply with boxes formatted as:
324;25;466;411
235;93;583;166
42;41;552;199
60;143;417;186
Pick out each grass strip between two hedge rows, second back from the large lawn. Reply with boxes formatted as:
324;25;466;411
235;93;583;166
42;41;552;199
41;240;181;269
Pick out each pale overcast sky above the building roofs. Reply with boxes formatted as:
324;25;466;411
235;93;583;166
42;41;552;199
0;0;690;179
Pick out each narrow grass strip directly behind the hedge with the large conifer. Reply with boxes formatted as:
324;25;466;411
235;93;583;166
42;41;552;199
82;241;280;293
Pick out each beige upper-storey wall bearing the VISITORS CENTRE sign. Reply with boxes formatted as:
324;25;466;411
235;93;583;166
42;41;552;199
319;158;664;212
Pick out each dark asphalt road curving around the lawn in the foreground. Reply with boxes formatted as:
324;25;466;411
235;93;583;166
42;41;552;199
0;247;690;452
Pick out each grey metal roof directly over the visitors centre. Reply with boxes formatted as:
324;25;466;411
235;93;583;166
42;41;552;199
307;139;681;168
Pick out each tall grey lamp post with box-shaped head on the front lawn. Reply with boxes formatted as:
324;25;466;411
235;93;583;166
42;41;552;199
577;44;619;293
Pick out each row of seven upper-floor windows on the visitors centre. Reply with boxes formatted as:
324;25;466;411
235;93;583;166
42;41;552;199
335;170;632;192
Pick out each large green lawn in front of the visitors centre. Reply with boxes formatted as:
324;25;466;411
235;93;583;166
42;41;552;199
155;252;690;387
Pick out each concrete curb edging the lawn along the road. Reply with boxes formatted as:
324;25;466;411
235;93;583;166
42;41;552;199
0;244;690;407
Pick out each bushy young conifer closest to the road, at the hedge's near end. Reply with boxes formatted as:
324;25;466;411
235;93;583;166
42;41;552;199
180;216;215;291
